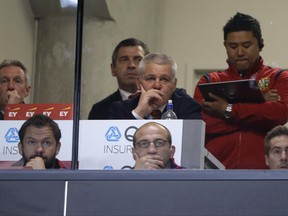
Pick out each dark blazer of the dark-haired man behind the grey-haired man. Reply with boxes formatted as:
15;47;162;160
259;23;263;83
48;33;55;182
88;89;122;119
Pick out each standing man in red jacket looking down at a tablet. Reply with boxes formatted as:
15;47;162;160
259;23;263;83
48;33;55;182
194;13;288;169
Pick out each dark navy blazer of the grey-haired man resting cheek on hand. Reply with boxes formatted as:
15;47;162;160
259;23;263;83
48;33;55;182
109;88;202;119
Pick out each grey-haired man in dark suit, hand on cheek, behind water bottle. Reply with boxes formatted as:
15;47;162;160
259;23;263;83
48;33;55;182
109;53;201;119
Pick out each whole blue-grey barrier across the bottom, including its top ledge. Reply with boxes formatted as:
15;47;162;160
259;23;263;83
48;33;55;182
0;170;288;216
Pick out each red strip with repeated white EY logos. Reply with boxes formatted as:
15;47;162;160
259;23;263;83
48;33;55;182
4;104;73;120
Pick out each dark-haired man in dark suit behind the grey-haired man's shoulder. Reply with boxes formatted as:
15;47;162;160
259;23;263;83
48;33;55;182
88;38;149;119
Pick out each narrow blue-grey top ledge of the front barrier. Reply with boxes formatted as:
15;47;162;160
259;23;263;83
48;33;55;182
0;169;288;181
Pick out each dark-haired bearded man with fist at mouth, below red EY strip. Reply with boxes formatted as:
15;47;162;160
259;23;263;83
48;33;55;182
12;114;65;169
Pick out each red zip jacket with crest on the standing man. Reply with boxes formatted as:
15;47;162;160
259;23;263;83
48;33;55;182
194;57;288;169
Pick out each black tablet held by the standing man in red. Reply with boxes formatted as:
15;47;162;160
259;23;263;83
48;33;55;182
198;79;265;103
